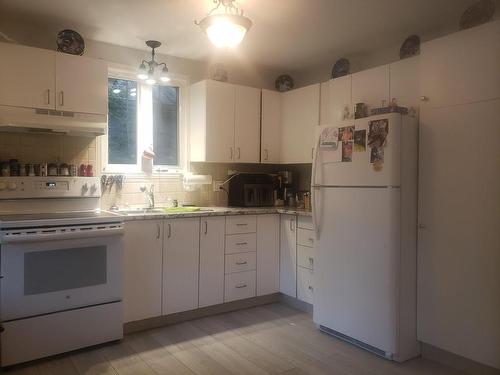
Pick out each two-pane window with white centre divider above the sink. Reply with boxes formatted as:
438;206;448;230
103;78;181;172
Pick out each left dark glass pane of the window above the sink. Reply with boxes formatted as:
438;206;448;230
108;78;137;164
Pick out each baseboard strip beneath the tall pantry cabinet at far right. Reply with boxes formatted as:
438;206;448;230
421;343;500;375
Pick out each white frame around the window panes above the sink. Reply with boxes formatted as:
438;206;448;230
98;67;188;176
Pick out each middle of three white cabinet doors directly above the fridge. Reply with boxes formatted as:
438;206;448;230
352;65;390;111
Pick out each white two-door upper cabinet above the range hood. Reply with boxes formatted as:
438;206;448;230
0;43;108;114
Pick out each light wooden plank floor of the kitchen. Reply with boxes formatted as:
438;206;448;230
2;303;463;375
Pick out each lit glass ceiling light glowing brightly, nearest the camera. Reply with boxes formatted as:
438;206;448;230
194;0;252;48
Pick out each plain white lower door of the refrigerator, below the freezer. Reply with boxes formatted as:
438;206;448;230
314;187;400;356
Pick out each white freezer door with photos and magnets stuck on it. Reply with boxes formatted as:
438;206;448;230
312;113;404;186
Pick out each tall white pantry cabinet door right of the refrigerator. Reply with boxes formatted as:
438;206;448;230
417;99;500;367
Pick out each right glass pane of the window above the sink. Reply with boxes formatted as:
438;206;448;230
153;86;179;165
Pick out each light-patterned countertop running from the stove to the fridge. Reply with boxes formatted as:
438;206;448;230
116;207;312;221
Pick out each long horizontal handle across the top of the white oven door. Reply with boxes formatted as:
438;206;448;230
0;225;124;244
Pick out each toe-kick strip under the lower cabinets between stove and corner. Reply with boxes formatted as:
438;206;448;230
123;293;280;334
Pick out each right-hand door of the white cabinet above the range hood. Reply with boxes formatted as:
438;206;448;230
56;53;108;114
